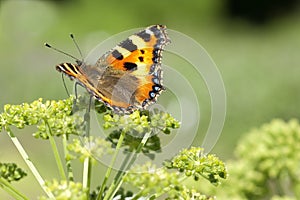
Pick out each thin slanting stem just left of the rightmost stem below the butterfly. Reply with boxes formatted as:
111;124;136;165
97;131;125;200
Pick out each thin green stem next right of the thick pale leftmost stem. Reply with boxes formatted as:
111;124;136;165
44;119;67;180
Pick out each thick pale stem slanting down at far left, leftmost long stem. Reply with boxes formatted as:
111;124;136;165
6;129;54;199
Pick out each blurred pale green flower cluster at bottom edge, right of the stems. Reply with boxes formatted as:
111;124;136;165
124;163;214;200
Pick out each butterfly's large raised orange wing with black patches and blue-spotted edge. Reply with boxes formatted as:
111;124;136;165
96;25;170;112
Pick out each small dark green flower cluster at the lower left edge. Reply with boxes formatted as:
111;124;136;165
0;163;27;185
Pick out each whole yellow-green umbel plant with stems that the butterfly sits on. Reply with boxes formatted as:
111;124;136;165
0;97;227;200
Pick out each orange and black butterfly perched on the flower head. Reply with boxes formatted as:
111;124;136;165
56;25;170;114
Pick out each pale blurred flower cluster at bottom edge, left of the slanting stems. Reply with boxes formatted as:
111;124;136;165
39;180;88;200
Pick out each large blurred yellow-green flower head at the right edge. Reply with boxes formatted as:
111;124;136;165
205;119;300;199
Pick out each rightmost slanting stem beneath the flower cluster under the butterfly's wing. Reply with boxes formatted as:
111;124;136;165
104;131;151;200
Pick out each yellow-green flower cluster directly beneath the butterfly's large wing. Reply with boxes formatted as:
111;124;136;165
103;110;180;155
